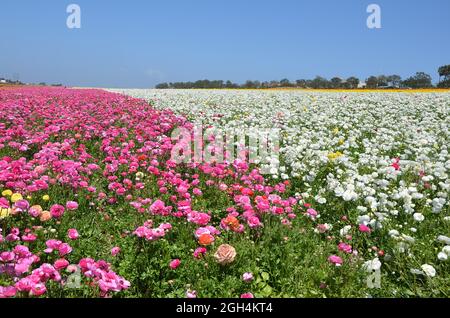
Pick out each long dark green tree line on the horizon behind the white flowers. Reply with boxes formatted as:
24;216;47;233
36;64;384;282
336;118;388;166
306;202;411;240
156;65;450;89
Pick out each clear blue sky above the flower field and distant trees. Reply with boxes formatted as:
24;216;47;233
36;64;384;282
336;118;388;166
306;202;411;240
0;0;450;88
